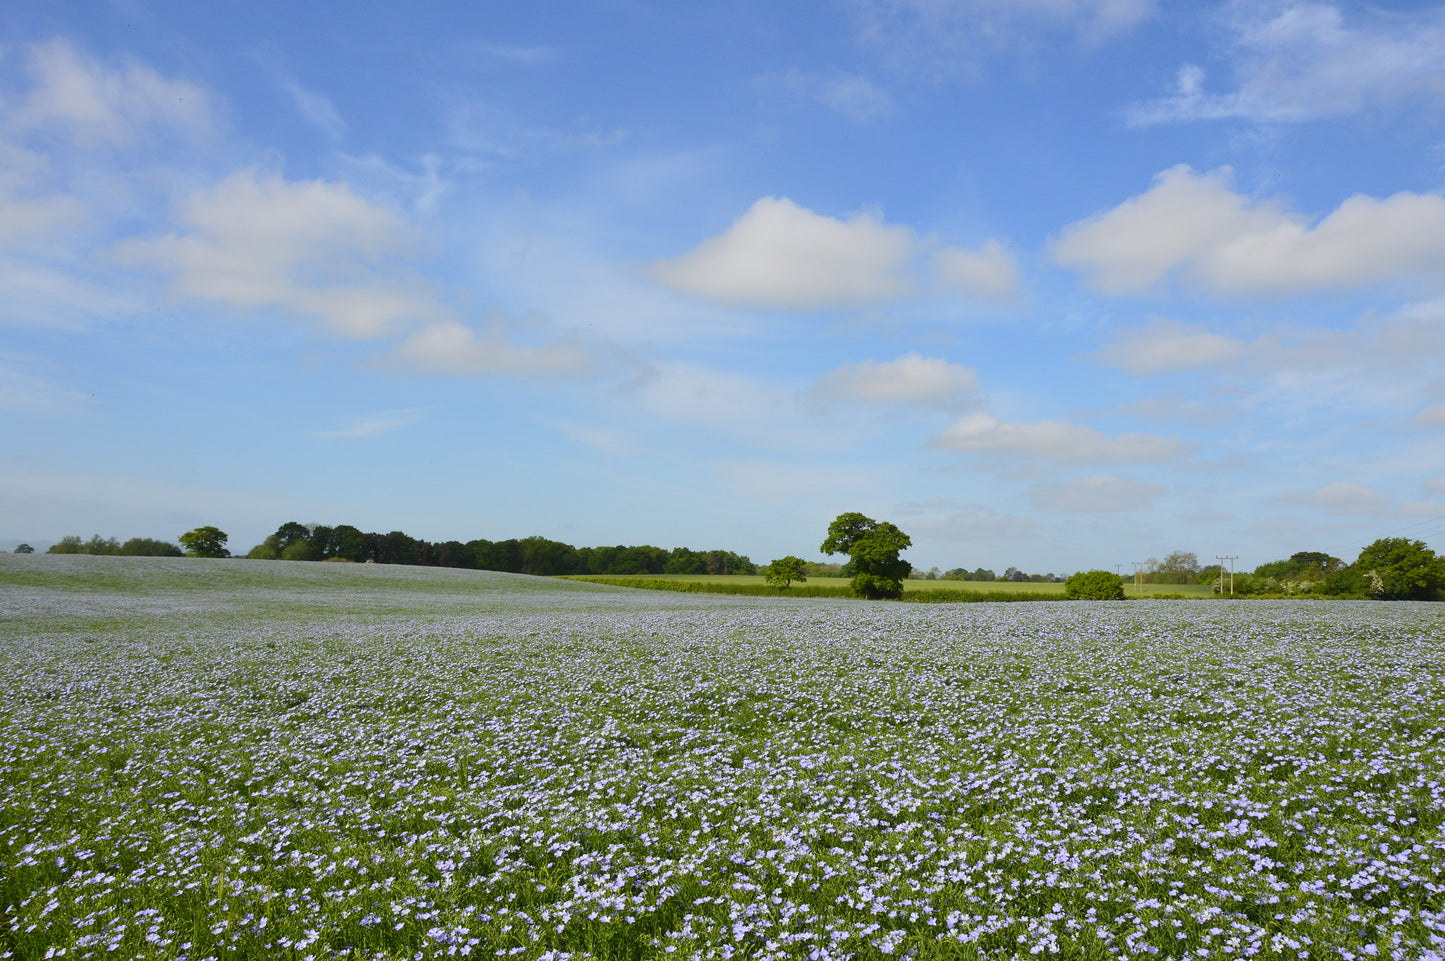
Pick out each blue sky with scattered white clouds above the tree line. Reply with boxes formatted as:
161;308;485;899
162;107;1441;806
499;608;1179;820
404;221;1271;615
0;0;1445;572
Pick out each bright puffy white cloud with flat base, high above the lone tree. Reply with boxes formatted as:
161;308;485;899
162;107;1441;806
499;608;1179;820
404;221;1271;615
652;197;915;311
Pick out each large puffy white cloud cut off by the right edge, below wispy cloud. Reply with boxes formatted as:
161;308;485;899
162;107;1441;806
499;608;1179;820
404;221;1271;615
1053;165;1445;295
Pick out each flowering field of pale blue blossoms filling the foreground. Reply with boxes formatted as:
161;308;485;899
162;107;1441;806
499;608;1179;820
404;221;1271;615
0;555;1445;961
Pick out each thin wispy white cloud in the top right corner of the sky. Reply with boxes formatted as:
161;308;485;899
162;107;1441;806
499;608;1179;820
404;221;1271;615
1124;3;1445;126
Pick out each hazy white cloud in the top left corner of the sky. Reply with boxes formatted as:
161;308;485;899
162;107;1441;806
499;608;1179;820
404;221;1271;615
4;40;212;147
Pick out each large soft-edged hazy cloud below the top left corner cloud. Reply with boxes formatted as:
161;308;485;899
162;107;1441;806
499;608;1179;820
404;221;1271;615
114;171;445;337
